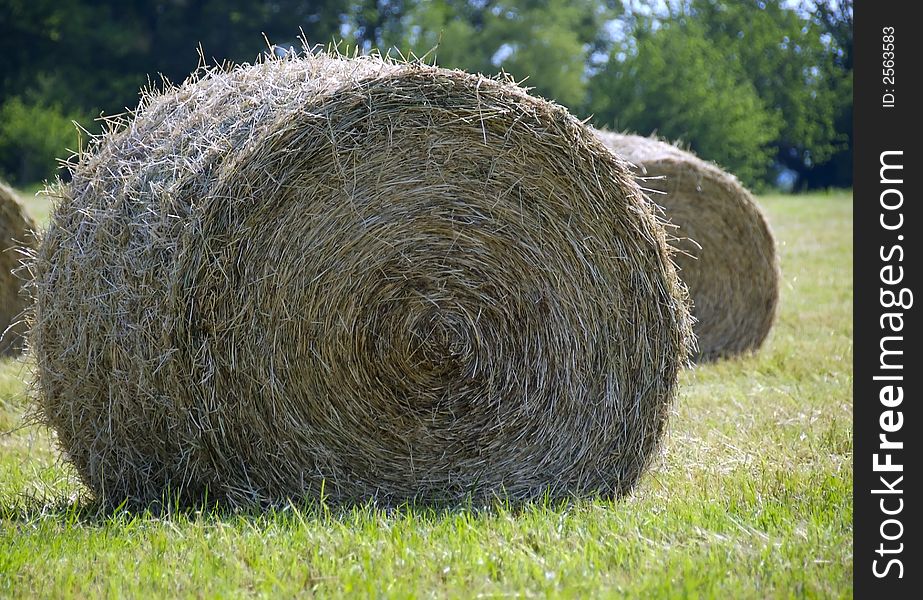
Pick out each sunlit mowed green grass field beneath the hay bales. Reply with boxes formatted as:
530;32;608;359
0;192;853;598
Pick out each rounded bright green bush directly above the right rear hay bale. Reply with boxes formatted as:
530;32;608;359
593;23;778;185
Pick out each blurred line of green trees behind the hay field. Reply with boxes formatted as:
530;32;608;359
0;0;852;189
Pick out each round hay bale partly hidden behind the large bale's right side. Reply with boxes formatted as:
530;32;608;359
597;131;780;361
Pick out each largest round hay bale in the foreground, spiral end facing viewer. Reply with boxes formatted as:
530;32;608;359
31;55;691;505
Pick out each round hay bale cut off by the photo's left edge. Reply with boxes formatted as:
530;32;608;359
0;181;35;356
